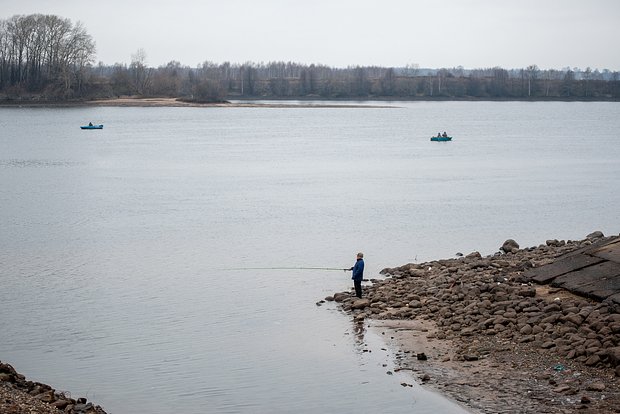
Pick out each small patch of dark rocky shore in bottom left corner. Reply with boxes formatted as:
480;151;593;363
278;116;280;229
0;361;106;414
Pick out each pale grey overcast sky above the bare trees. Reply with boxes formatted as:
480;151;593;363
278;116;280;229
0;0;620;71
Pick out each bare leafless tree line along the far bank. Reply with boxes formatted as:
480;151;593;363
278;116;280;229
0;14;620;102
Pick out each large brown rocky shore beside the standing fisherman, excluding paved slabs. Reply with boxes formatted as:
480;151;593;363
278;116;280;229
326;232;620;414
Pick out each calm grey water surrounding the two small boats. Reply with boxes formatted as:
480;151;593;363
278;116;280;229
0;102;620;414
